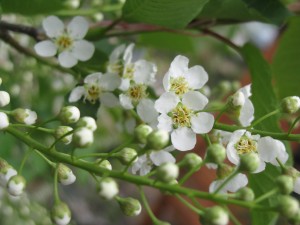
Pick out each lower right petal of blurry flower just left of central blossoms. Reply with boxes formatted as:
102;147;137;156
136;99;158;123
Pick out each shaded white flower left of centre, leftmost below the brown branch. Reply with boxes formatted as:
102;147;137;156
69;73;121;107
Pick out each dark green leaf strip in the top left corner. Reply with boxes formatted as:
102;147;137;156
0;0;63;15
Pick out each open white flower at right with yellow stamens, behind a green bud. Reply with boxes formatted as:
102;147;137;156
227;130;288;173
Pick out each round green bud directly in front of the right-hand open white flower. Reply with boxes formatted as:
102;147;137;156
239;152;260;173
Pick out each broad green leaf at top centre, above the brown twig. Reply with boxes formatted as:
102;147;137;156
123;0;209;28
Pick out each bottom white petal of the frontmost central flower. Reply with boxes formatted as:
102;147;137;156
171;127;197;151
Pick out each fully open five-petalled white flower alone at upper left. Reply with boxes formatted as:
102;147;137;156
34;16;95;68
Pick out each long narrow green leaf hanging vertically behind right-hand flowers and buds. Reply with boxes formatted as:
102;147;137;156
241;44;280;225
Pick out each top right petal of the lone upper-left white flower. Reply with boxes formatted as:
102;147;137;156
67;16;89;39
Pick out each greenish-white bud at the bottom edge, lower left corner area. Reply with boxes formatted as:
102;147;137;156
51;202;71;225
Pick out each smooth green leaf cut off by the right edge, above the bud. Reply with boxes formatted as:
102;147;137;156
272;17;300;99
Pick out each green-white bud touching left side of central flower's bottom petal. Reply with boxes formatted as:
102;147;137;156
147;130;170;150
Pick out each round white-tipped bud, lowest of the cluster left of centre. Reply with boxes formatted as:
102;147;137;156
72;127;94;148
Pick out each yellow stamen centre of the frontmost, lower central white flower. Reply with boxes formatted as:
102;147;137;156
172;105;192;128
